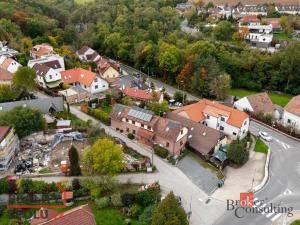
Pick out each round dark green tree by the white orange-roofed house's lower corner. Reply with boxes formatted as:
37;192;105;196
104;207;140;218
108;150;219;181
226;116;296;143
227;139;249;166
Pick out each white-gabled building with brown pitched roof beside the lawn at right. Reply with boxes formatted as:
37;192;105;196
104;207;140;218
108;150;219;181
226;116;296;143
234;92;276;115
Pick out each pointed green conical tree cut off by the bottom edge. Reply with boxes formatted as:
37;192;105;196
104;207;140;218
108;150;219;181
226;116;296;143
151;192;189;225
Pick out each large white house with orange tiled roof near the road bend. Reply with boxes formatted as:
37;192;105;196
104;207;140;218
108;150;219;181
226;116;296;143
173;99;250;139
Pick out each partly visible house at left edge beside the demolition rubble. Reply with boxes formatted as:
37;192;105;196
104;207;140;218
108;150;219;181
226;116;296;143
0;126;19;171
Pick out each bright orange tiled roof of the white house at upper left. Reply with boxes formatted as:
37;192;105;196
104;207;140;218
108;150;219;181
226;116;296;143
61;68;96;86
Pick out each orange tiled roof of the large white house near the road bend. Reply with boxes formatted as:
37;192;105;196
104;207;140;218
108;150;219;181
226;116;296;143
174;99;248;127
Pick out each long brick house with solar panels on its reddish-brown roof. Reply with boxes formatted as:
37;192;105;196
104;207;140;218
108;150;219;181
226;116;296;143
110;104;188;156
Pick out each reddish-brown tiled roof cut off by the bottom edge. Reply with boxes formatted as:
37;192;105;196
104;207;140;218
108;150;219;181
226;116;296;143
31;205;96;225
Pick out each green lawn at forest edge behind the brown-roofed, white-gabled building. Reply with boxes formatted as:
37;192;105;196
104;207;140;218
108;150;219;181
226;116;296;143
227;88;293;107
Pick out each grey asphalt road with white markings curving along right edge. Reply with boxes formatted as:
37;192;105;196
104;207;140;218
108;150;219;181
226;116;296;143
215;122;300;225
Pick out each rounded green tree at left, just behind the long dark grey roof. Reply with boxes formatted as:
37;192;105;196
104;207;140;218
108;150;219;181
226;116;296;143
12;66;37;96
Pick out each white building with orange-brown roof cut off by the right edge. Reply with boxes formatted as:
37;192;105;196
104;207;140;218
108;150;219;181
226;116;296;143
282;95;300;130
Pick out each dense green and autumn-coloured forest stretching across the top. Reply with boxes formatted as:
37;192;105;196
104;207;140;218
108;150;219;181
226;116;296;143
0;0;300;99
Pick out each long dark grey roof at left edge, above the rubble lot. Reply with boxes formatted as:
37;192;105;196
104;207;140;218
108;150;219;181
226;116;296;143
0;97;64;114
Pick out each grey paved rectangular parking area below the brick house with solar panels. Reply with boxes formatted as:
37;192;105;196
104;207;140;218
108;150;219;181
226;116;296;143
177;154;219;195
